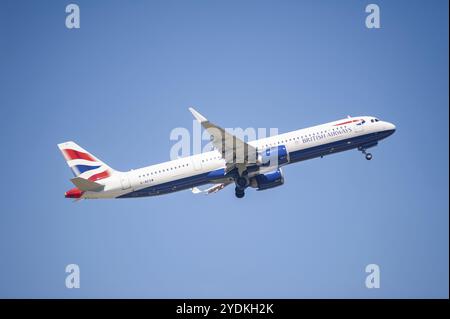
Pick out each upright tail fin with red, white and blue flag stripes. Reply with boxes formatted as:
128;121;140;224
58;142;114;182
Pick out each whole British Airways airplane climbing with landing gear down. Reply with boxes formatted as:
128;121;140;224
58;108;396;201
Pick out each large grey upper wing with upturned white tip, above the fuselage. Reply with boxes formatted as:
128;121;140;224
189;107;257;172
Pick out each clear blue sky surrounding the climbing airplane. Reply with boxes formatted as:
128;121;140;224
0;0;449;298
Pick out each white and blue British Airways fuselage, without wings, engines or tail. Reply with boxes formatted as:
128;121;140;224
82;116;395;198
